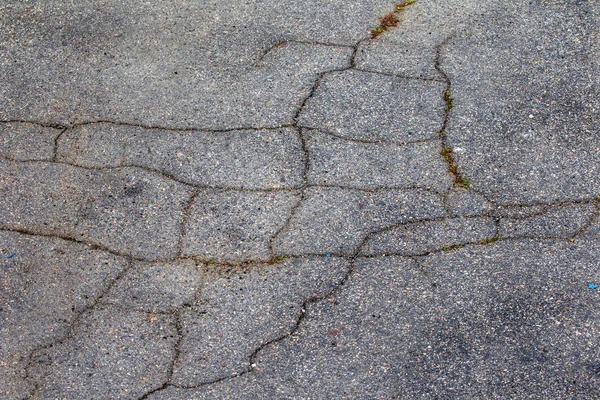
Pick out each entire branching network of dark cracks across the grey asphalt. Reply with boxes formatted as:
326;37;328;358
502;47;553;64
0;1;600;400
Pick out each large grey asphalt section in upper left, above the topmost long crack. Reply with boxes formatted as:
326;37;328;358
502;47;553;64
0;0;393;129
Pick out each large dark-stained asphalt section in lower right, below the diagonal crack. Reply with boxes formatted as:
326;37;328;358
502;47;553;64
150;240;600;400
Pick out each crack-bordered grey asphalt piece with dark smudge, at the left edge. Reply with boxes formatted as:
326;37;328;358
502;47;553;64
0;160;191;260
